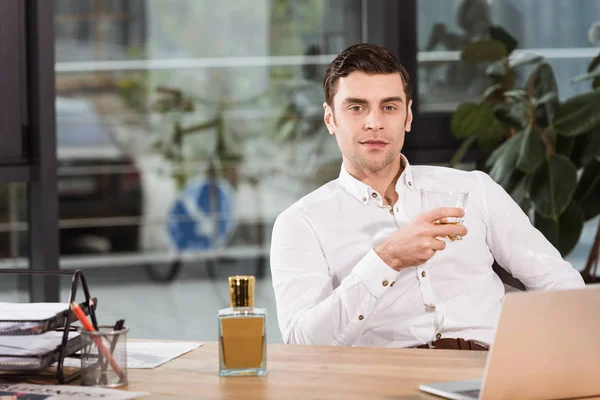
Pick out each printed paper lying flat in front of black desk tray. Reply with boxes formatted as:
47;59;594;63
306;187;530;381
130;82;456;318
0;382;148;400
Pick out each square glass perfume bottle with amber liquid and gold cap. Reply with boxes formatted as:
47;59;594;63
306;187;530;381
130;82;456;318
218;275;267;376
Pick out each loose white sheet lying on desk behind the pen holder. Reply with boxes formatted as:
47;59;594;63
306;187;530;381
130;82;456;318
64;342;202;369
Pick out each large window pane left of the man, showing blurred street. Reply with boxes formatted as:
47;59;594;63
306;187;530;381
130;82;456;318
55;0;363;341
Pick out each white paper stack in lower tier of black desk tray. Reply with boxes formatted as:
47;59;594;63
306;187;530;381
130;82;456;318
0;331;79;356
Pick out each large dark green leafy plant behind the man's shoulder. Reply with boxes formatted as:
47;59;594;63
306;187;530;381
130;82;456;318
450;26;600;280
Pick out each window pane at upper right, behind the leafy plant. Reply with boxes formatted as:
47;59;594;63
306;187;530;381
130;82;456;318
417;0;600;112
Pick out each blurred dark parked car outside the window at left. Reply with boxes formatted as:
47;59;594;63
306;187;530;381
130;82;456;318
56;96;142;254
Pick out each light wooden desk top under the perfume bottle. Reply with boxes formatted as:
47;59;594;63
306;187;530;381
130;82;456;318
122;343;487;400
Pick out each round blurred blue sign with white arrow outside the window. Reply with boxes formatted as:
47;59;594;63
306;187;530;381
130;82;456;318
167;179;235;250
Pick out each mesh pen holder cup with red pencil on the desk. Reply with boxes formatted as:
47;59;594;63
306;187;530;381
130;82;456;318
80;326;129;387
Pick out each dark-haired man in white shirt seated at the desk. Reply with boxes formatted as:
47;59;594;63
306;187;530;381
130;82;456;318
271;44;584;350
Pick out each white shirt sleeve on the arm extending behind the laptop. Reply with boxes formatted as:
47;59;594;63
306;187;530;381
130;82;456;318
477;171;585;290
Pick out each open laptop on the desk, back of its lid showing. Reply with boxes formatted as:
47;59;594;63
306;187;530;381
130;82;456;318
419;284;600;400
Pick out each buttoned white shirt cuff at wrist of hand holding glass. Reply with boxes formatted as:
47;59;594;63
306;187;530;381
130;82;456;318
352;249;400;297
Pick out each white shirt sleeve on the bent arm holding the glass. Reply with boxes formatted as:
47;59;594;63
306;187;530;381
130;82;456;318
271;210;399;346
